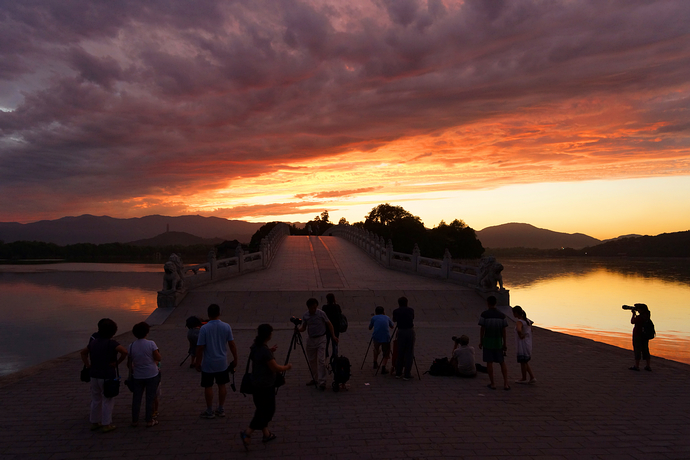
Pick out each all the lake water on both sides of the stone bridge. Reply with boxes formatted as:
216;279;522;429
0;259;690;376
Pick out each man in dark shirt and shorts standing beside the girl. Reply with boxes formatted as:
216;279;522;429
479;296;510;390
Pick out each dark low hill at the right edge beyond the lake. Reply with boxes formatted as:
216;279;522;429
583;230;690;257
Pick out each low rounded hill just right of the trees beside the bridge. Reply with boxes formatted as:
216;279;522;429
477;223;600;249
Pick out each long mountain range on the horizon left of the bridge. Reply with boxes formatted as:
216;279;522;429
0;214;263;245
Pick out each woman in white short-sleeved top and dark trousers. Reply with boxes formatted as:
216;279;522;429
127;322;161;427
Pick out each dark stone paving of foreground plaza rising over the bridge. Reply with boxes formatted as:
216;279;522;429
0;237;690;459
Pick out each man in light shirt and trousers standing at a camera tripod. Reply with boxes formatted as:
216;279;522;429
295;297;338;391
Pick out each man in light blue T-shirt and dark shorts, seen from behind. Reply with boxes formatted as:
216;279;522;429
196;304;237;418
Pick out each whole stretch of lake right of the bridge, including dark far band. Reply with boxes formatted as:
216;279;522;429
502;259;690;363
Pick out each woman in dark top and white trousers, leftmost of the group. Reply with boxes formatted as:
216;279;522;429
81;318;127;433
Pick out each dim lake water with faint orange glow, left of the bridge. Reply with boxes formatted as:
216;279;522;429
0;264;161;375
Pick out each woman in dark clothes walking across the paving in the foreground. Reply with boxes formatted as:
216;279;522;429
240;324;292;450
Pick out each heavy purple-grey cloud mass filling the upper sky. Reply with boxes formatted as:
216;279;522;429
0;0;690;220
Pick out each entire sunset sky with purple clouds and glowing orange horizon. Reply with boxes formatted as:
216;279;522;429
0;0;690;239
